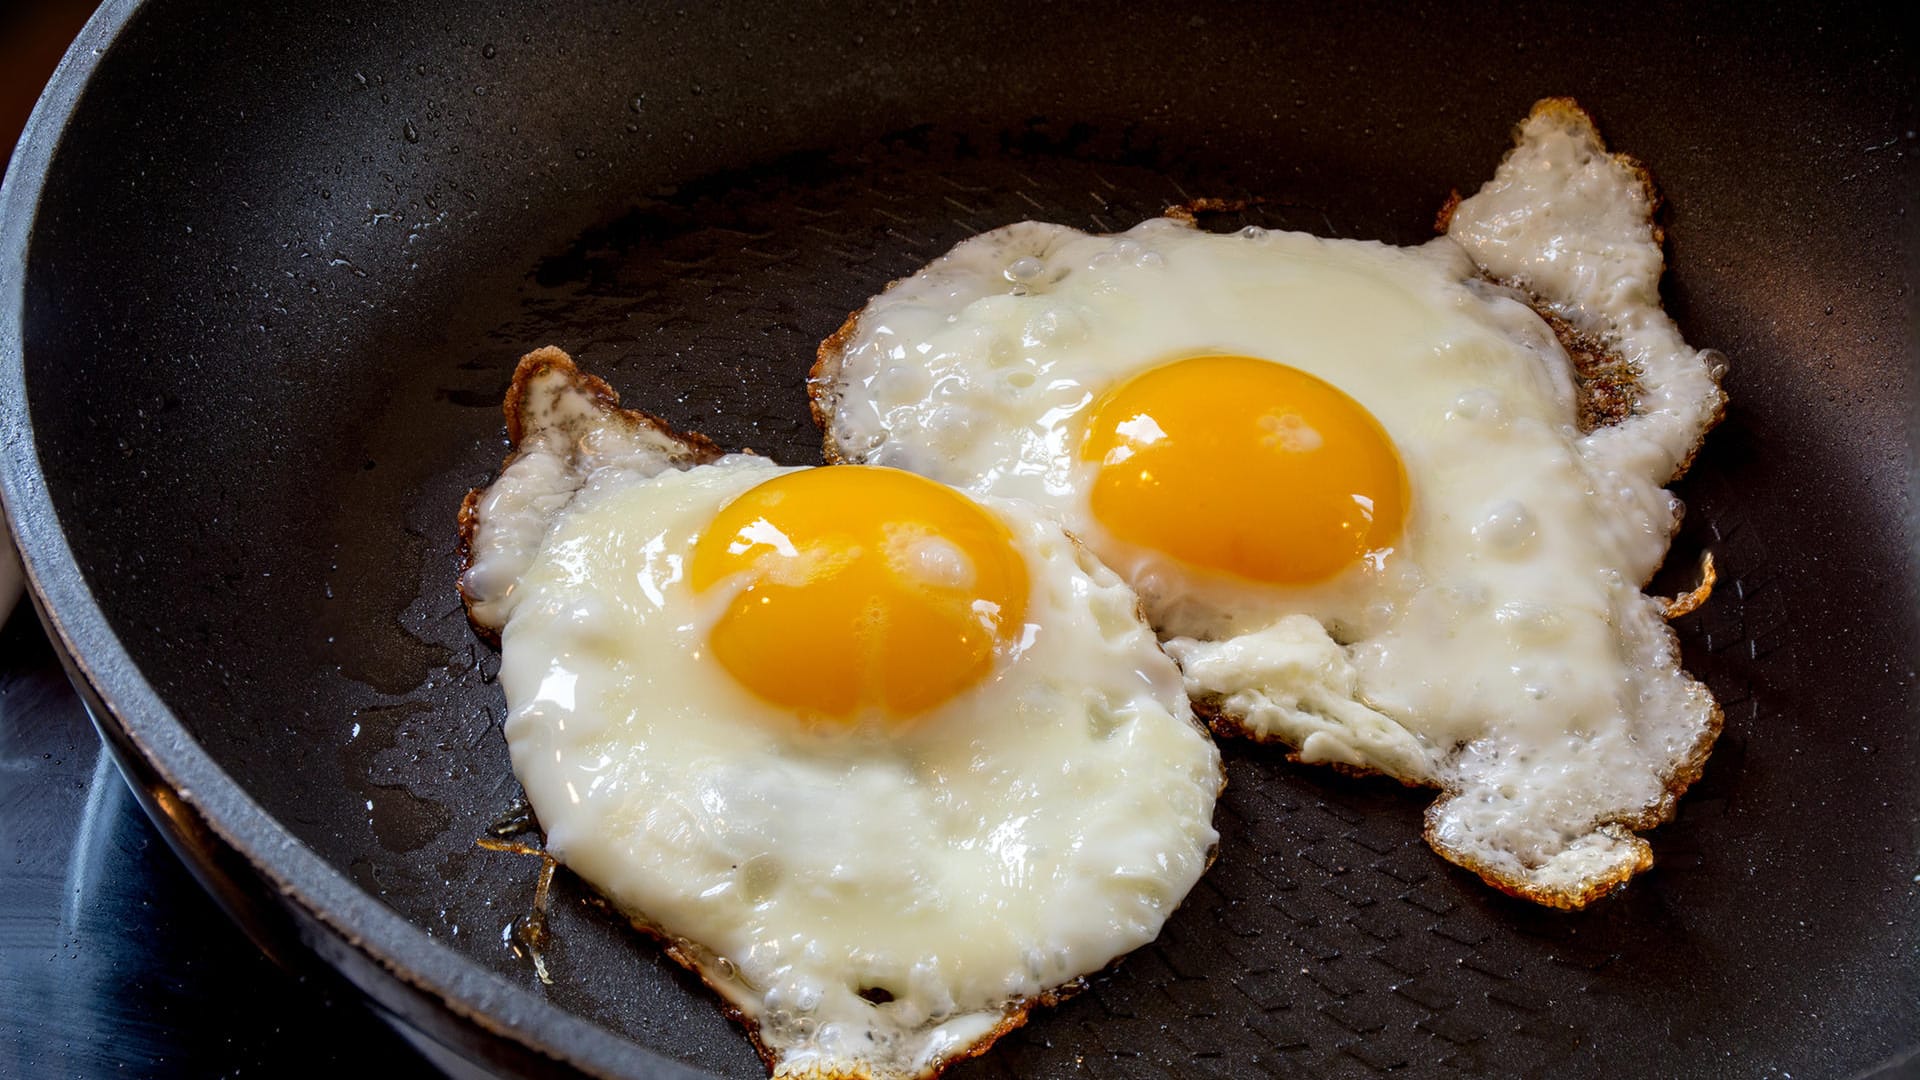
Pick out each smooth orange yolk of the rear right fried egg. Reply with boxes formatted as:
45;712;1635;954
1081;356;1407;584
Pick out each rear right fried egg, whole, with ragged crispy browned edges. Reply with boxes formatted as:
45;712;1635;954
812;102;1722;907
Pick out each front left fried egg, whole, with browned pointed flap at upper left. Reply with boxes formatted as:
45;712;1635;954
463;350;1223;1078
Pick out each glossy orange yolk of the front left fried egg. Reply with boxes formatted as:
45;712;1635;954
687;465;1029;724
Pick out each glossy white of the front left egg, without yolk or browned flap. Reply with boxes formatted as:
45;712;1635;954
499;449;1223;1078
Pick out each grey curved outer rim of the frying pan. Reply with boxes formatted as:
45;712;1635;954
0;0;705;1080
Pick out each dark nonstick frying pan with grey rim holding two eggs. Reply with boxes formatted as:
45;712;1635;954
0;0;1920;1076
